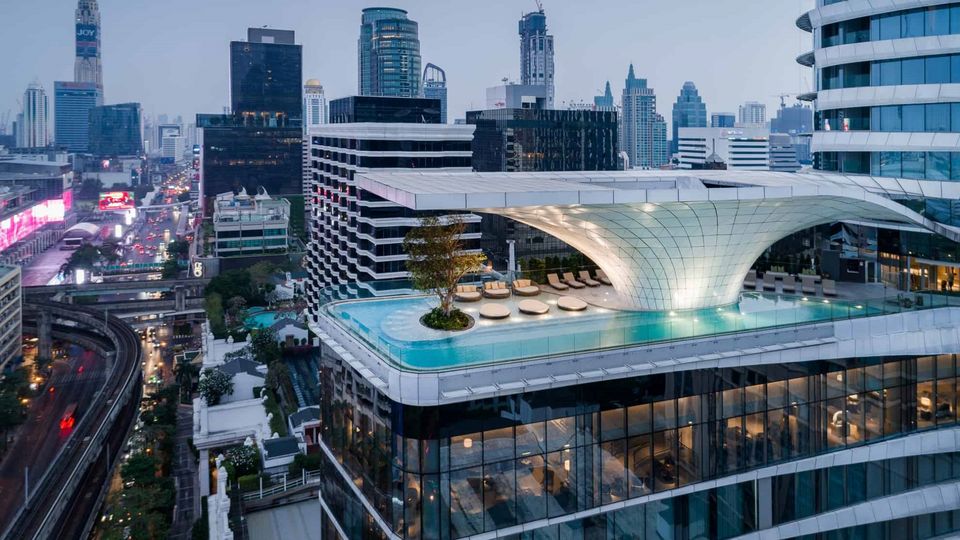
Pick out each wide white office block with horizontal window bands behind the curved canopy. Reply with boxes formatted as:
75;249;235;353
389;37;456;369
677;128;770;171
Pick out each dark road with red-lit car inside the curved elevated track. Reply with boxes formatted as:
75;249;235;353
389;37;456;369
0;345;106;530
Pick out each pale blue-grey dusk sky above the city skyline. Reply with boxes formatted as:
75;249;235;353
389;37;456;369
0;0;813;131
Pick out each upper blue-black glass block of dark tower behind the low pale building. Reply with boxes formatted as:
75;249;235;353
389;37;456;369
230;28;303;127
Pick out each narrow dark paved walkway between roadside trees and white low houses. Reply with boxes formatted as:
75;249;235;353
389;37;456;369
169;404;200;540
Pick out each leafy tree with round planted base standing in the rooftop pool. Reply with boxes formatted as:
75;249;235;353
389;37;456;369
403;216;484;330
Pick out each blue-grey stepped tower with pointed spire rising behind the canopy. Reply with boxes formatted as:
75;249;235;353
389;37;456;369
620;64;669;169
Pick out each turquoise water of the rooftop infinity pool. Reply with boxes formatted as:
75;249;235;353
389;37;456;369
327;293;884;370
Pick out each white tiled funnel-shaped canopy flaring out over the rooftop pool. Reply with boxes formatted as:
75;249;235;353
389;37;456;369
356;171;960;310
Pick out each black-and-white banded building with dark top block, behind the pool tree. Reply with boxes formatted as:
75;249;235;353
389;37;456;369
307;96;480;298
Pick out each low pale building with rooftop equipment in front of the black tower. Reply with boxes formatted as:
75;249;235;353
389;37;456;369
213;188;290;257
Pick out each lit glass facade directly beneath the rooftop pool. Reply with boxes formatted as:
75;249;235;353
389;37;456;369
320;349;957;539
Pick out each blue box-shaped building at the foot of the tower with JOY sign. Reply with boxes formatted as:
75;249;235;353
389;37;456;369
53;81;103;153
